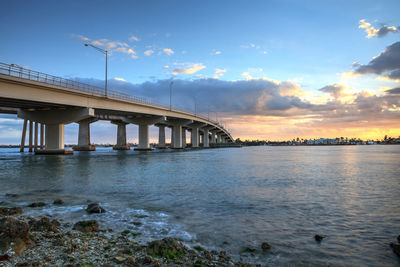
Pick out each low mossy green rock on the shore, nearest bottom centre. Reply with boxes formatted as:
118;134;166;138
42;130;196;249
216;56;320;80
146;237;186;260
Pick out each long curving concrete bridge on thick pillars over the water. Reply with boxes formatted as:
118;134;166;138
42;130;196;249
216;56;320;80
0;63;234;154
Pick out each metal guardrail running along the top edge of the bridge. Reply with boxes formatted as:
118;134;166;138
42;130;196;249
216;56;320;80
0;62;232;138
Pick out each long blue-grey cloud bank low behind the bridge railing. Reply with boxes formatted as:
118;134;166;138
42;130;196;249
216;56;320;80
77;79;312;115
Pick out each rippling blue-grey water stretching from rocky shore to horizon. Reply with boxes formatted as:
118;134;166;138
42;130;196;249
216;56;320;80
0;145;400;266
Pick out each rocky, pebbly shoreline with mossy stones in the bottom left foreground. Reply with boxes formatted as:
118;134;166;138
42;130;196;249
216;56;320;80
0;204;251;267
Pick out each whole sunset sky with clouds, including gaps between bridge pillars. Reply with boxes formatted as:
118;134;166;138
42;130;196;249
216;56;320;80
0;0;400;144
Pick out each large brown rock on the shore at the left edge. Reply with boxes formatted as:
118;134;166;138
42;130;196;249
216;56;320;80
0;217;32;256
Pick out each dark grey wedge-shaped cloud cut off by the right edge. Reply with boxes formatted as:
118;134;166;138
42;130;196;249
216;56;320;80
353;42;400;74
